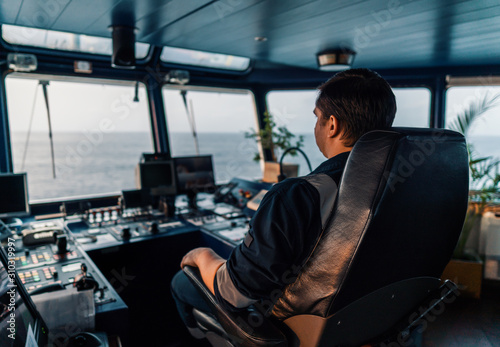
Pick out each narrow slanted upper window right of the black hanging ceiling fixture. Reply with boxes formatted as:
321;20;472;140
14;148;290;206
160;47;250;71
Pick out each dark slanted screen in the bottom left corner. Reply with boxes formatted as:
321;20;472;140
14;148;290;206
0;247;48;347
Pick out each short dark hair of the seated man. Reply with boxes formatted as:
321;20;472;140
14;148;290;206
316;69;396;147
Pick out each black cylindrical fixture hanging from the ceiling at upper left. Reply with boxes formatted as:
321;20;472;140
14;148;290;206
110;25;136;69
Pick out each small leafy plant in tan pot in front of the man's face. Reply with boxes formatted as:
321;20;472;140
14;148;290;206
245;111;304;182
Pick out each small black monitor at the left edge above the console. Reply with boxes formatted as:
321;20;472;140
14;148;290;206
0;173;30;218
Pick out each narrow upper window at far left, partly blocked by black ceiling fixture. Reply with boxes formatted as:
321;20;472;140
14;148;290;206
2;24;150;59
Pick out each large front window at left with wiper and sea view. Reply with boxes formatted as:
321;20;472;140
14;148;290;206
5;75;153;200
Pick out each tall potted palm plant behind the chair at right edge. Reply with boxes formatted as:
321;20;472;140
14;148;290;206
442;94;500;298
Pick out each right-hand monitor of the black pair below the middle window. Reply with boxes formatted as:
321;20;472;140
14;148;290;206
174;155;215;194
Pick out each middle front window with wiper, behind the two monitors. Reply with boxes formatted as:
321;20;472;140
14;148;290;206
163;87;262;183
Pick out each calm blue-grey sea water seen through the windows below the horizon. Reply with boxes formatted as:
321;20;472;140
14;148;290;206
11;132;500;201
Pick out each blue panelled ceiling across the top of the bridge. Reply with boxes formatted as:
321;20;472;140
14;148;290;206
0;0;500;68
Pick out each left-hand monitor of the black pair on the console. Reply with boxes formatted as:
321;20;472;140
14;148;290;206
137;160;177;196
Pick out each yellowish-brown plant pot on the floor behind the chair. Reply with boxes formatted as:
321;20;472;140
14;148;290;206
441;259;483;299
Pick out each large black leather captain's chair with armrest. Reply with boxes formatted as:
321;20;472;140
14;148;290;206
184;128;469;346
